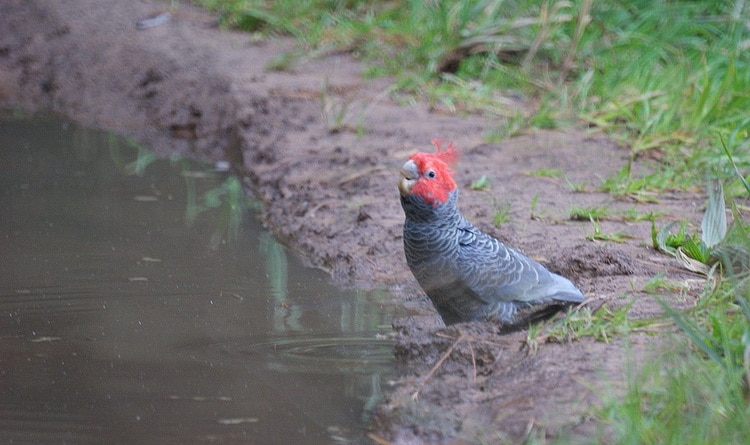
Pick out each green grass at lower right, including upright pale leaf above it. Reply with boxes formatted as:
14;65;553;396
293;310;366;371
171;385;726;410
596;169;750;444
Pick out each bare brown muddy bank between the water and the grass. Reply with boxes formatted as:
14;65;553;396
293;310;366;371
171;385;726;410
0;0;705;443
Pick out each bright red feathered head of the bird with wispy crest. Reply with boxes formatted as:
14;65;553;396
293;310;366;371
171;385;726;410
398;139;458;208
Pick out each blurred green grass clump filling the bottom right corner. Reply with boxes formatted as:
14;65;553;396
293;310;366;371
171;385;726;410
595;278;750;444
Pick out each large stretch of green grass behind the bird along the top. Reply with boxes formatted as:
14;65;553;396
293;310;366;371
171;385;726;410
198;0;750;195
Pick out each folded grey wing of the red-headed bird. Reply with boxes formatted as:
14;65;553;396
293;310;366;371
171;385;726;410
460;222;583;303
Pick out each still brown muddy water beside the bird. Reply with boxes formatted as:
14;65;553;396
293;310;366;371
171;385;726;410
0;115;400;443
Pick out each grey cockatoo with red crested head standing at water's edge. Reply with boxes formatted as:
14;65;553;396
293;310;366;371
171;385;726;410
398;139;584;325
